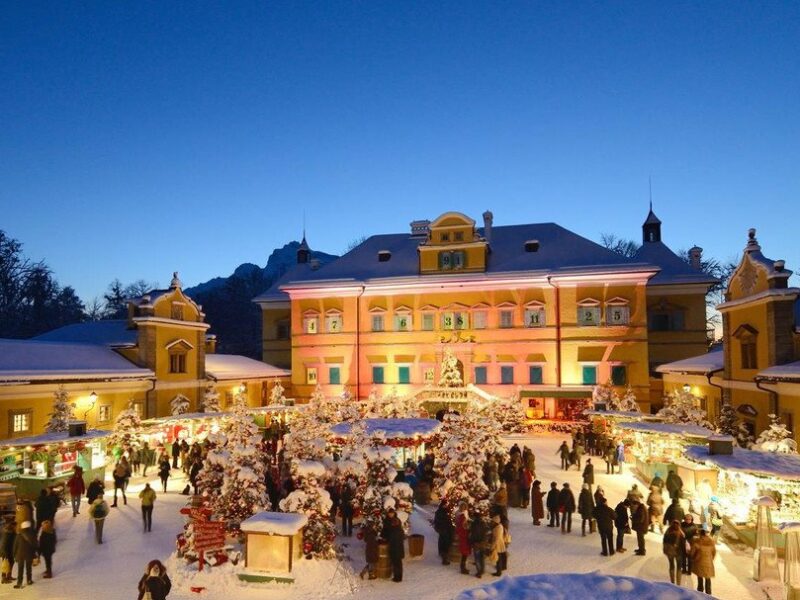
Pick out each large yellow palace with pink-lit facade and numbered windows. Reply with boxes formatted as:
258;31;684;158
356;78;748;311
254;210;716;418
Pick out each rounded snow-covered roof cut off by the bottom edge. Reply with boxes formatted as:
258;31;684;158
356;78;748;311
456;571;708;600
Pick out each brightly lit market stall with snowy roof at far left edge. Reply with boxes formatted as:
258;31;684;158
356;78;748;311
0;429;109;499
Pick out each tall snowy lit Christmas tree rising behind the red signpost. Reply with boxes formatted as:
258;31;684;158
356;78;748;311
214;393;269;530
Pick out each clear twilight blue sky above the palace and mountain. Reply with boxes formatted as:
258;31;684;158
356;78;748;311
0;0;800;299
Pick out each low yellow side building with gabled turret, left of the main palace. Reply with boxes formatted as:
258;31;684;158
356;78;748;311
0;274;288;439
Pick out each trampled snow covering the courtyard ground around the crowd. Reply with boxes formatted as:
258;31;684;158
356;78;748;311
14;435;775;600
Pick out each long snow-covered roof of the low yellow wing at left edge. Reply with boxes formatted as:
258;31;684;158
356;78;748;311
0;339;155;382
